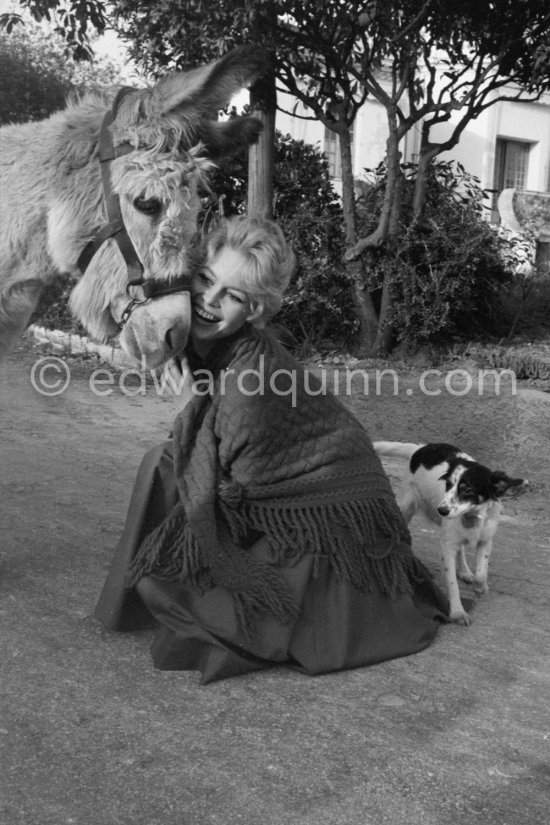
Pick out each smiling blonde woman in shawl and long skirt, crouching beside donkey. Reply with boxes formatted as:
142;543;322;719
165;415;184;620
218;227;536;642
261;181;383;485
96;212;445;684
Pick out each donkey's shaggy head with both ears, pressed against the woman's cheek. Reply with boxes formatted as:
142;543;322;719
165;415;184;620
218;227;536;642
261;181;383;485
69;48;263;367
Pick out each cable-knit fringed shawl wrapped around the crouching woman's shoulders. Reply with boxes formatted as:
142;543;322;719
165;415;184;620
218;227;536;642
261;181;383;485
128;328;425;624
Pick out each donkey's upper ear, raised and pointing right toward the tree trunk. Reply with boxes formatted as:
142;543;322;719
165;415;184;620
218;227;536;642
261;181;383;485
154;45;267;117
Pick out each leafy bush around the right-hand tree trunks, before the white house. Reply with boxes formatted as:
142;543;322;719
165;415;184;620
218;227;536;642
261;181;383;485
359;161;512;346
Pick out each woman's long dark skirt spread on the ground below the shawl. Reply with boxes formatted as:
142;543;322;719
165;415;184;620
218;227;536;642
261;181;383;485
95;442;445;684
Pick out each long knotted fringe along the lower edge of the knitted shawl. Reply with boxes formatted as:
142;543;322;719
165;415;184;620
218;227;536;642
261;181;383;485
127;490;431;628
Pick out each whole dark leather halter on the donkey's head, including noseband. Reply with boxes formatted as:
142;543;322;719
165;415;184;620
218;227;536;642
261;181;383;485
77;86;190;330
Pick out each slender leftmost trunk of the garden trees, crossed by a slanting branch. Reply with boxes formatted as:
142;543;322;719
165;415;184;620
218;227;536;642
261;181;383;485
338;127;378;355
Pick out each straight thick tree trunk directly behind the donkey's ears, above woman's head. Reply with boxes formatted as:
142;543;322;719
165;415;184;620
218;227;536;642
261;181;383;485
248;63;277;218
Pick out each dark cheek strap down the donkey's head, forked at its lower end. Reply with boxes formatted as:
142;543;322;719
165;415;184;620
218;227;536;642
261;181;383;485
77;86;147;280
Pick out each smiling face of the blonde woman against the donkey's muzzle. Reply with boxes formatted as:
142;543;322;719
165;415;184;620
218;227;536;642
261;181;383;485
191;241;257;353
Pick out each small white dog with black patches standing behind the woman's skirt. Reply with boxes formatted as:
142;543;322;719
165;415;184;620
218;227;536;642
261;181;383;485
374;441;528;625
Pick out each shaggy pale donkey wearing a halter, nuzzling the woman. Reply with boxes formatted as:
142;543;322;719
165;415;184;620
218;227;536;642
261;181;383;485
0;46;264;368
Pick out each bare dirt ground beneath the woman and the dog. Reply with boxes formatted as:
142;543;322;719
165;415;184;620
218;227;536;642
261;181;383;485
0;334;550;825
